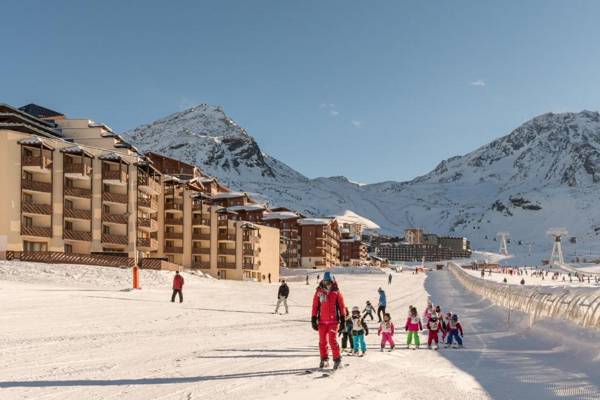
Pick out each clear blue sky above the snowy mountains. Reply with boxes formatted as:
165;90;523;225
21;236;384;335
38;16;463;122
0;0;600;182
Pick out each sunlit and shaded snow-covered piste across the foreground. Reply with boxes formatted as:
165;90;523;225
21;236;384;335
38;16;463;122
0;262;600;400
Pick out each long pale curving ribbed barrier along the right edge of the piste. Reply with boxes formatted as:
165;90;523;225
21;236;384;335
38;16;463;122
448;262;600;329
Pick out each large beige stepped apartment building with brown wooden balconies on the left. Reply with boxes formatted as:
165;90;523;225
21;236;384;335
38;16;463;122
0;104;279;281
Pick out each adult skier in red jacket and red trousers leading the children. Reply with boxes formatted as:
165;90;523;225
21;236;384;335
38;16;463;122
311;271;346;369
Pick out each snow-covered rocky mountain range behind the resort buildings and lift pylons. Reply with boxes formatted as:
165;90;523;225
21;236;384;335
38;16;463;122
127;104;600;256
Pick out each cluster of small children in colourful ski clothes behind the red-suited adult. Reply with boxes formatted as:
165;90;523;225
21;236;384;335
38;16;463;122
338;301;463;357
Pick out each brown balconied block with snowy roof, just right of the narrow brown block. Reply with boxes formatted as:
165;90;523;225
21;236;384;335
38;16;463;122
298;218;340;268
